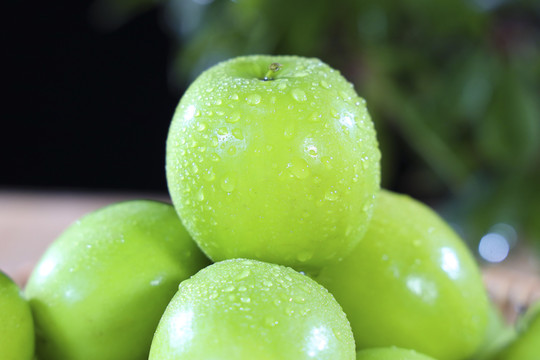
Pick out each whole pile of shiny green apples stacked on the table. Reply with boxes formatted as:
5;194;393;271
0;56;540;360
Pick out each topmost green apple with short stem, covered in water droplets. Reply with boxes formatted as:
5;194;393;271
166;56;380;268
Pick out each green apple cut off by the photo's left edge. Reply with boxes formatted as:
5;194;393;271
0;271;34;360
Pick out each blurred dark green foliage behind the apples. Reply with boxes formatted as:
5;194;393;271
95;0;540;250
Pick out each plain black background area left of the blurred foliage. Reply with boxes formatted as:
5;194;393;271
4;1;177;191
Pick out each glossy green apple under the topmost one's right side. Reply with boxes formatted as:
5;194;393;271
317;190;489;360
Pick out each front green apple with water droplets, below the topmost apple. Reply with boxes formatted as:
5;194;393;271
149;259;355;360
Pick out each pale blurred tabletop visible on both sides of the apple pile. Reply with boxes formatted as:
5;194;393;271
0;189;540;322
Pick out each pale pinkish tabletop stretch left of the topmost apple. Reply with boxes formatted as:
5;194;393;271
0;190;169;286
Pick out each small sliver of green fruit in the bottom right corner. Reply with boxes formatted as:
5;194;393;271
494;301;540;360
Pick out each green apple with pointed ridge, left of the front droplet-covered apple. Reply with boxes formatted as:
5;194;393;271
26;200;208;360
